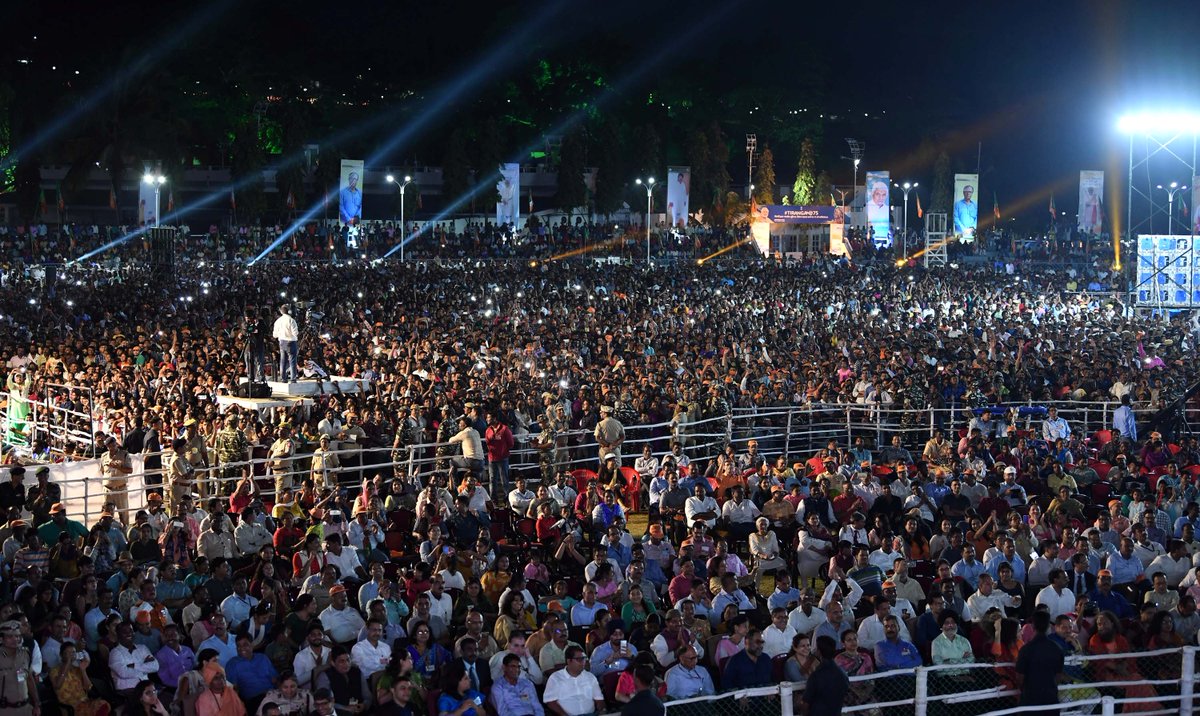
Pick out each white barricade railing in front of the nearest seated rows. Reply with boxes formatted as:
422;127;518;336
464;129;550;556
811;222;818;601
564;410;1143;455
633;646;1200;716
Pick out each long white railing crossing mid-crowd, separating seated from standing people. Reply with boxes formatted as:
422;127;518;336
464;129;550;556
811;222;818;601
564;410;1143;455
0;393;1161;527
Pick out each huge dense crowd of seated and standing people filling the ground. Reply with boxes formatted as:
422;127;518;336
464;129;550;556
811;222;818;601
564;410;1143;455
0;239;1200;716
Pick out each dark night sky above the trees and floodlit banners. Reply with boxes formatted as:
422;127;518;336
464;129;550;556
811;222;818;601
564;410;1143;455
7;0;1200;223
